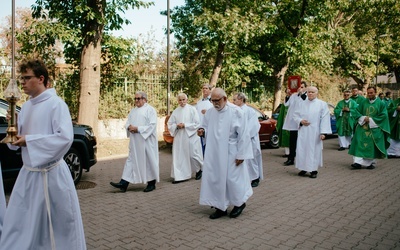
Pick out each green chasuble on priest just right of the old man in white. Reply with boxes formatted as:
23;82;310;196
333;99;358;136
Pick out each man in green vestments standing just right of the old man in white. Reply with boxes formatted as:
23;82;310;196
333;90;358;151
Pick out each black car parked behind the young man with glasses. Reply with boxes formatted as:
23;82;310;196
0;99;97;184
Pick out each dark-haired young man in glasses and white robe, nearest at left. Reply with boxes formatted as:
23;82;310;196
0;60;86;250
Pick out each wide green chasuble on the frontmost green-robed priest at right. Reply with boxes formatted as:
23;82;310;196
349;98;390;159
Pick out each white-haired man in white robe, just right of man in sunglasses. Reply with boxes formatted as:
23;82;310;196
168;93;203;184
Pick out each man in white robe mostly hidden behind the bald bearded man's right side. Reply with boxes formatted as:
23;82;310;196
233;93;264;187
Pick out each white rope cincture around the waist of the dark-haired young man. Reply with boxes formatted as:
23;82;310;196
24;159;62;250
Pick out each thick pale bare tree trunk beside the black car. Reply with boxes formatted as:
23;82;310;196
78;39;101;135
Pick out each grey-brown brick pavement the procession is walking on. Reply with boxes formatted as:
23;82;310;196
16;138;400;250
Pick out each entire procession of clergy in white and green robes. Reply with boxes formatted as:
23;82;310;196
0;60;400;250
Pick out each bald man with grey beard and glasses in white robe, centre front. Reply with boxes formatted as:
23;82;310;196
197;88;253;219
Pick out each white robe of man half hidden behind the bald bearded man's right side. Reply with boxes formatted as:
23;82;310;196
241;104;264;180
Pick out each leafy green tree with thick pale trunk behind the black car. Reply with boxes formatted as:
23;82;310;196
32;0;153;132
